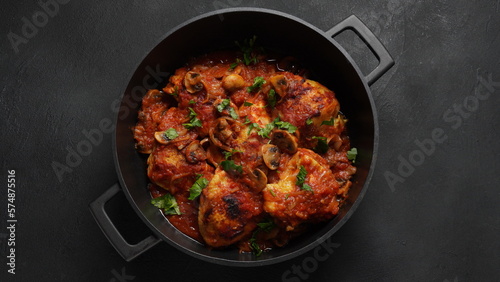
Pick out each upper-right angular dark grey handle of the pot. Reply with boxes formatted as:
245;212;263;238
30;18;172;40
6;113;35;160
326;15;394;85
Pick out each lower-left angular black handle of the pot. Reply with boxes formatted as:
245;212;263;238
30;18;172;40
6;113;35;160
89;184;161;261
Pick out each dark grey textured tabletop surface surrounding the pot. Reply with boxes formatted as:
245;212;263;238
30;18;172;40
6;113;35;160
0;0;500;282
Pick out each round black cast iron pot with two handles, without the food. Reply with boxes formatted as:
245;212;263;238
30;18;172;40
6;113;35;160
90;8;394;266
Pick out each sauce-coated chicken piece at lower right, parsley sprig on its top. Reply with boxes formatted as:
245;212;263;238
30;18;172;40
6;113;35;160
263;148;339;231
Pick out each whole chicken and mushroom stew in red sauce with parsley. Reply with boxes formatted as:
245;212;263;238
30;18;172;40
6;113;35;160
134;38;356;255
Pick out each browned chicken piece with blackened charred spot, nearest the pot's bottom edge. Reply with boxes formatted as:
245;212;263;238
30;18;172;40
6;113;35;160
198;168;262;248
